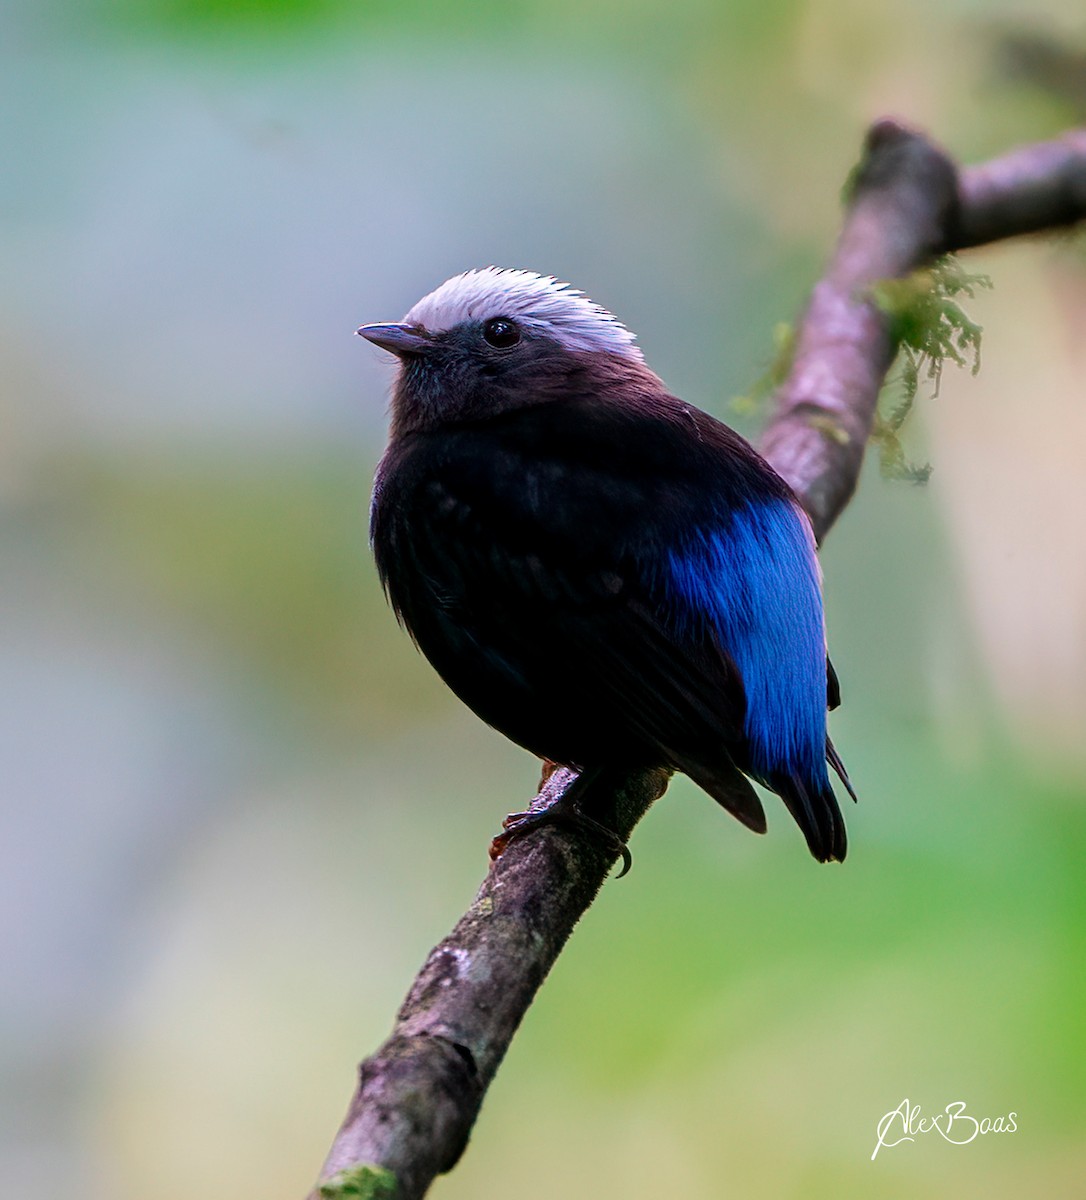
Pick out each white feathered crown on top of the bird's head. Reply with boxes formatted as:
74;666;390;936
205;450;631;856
403;266;642;359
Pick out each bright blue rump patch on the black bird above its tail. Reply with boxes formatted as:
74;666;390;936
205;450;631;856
667;499;829;791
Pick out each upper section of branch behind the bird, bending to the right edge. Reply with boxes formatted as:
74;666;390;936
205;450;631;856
761;120;1086;541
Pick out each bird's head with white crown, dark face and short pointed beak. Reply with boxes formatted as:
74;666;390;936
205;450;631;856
358;266;659;434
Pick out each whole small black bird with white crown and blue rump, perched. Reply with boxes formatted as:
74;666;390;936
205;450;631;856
358;266;852;862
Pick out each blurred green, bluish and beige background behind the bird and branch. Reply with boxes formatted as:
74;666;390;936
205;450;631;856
0;0;1086;1200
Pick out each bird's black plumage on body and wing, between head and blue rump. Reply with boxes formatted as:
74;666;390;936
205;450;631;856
371;397;786;764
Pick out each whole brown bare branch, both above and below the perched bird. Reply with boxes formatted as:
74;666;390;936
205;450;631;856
304;120;1086;1200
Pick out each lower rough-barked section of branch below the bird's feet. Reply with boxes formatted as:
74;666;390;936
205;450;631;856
316;768;667;1200
